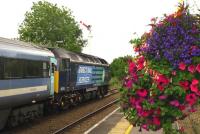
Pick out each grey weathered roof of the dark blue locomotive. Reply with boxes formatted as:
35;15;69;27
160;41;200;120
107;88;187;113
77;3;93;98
52;48;108;65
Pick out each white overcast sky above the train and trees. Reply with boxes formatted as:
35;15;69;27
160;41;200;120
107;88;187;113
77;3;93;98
0;0;200;62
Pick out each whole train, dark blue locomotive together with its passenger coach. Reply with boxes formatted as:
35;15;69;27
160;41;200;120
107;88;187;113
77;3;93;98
0;37;110;130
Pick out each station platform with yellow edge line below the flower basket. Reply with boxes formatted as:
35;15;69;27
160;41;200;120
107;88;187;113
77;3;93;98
84;108;162;134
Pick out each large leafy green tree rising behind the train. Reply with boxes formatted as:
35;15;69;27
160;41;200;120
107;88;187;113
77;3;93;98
18;1;87;52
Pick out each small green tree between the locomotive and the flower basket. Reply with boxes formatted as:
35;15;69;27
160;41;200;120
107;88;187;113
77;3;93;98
110;56;132;80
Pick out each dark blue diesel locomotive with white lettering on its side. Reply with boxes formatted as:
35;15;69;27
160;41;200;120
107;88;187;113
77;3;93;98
52;48;109;107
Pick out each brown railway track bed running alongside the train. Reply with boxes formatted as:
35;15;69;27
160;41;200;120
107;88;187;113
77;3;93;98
3;89;119;134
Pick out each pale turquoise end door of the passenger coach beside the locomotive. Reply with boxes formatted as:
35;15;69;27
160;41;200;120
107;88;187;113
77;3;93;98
50;57;57;96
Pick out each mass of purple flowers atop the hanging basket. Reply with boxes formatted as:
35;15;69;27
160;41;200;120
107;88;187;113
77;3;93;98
141;14;200;68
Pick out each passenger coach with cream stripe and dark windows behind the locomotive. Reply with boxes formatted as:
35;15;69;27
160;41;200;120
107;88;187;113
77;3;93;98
0;38;56;129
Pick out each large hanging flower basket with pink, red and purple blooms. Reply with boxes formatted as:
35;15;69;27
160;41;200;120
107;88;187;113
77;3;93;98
120;5;200;134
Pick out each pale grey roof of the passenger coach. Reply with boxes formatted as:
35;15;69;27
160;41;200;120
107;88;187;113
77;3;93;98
0;37;54;60
